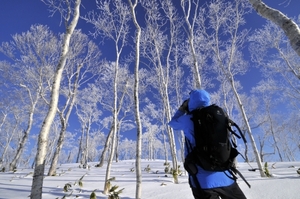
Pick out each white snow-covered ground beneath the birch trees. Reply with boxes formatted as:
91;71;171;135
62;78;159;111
0;160;300;199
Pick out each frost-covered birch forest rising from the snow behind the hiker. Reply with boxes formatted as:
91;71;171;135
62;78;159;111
0;0;300;198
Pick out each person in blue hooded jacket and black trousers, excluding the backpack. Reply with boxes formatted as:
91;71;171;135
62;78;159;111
169;89;246;199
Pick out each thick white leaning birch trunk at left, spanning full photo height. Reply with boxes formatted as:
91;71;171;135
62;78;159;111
30;0;81;199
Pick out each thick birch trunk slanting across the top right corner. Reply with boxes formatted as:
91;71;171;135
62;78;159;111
249;0;300;56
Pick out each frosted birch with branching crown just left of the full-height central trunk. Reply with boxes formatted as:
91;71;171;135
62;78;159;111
85;0;130;194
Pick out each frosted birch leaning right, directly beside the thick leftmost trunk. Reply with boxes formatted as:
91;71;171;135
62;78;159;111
48;30;102;176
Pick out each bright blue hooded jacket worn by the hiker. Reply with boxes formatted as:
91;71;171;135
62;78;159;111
169;90;234;189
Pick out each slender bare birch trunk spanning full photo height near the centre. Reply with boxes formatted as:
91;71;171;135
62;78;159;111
128;0;142;199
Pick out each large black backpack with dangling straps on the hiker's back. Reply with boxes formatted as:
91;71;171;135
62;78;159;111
189;104;250;186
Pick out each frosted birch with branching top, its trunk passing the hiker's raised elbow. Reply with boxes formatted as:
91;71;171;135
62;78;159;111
142;0;178;184
